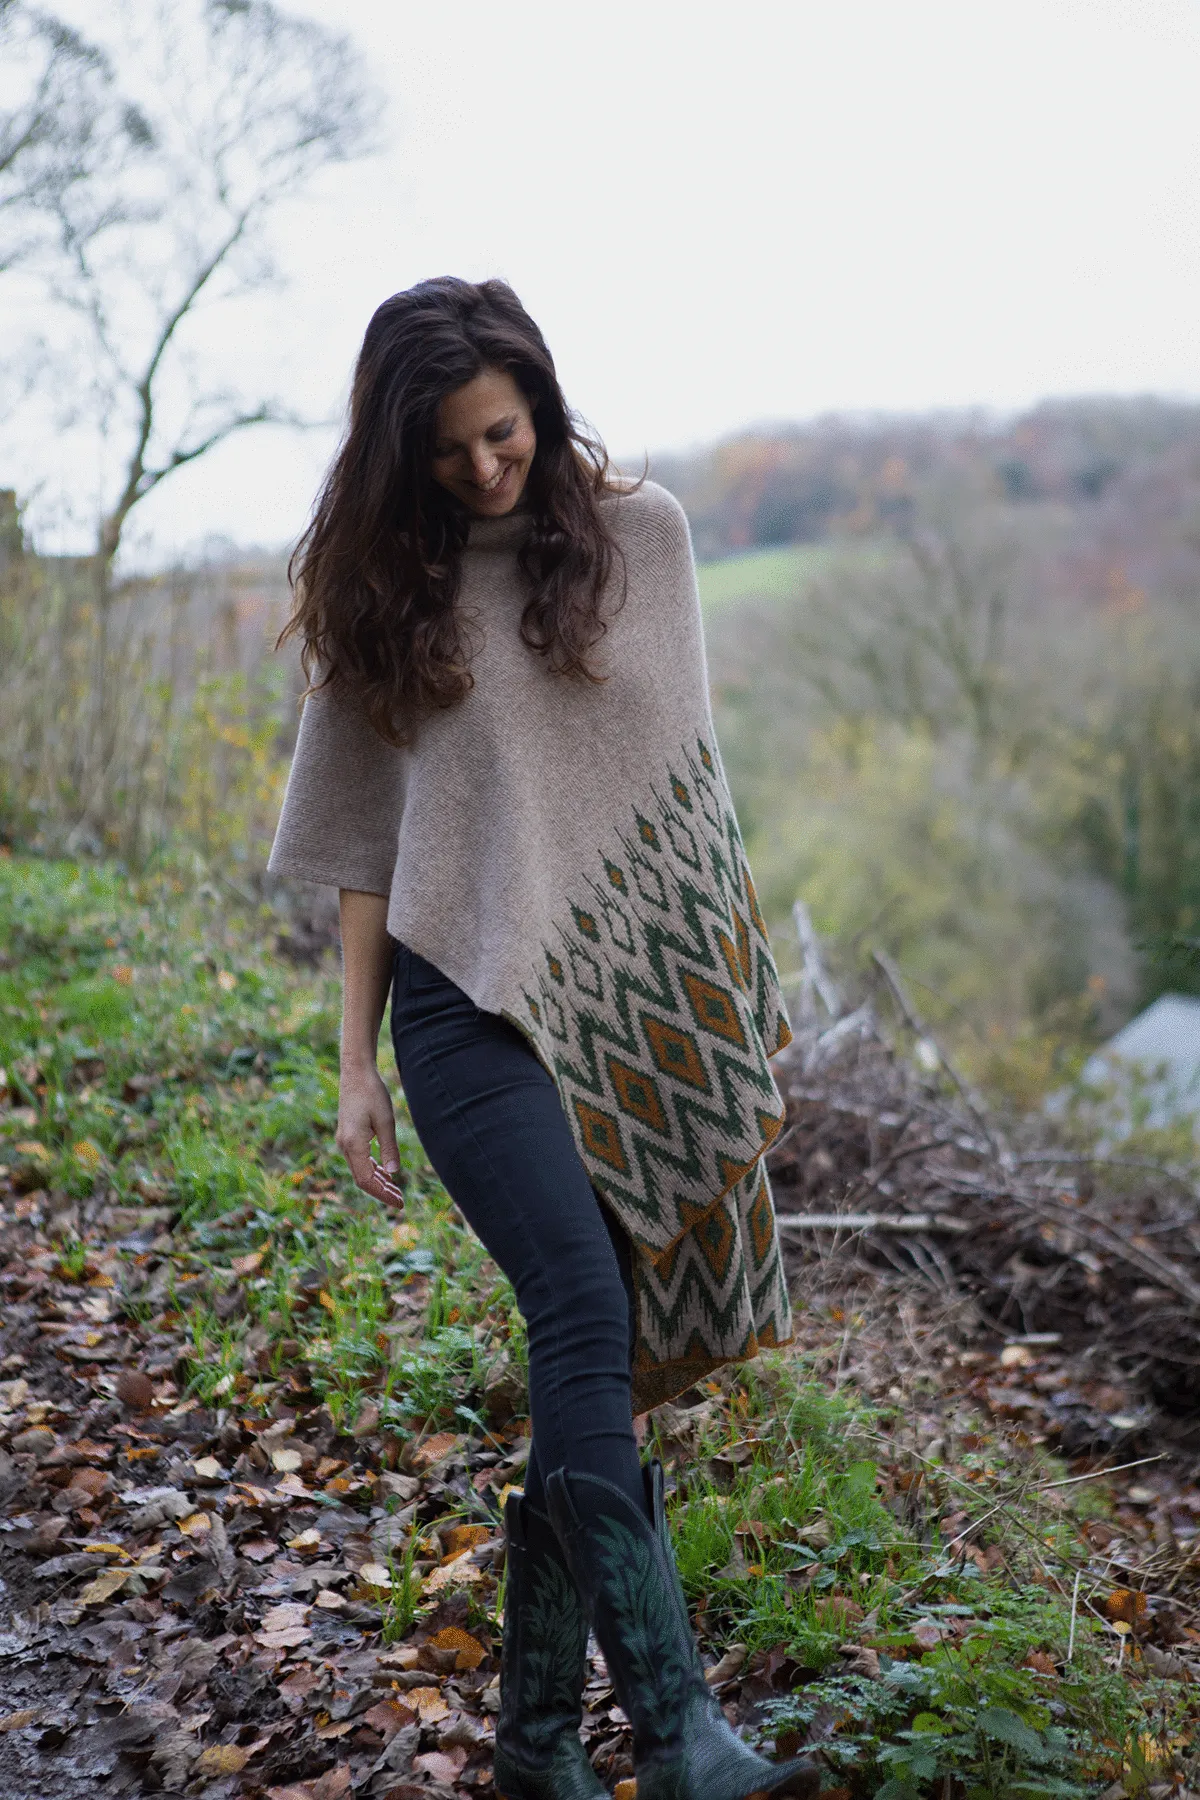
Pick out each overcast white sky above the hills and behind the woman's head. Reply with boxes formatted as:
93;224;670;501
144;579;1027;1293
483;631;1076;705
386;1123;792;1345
18;0;1200;554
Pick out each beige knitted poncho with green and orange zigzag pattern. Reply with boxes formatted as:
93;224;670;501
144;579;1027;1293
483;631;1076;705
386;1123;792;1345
270;482;792;1409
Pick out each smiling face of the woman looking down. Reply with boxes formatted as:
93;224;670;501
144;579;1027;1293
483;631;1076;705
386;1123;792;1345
434;369;538;518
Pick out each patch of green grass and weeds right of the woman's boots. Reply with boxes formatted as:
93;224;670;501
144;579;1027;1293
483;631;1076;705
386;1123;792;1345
664;1355;1196;1800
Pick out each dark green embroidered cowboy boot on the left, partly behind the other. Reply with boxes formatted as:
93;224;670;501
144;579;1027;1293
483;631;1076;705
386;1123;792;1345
495;1494;608;1800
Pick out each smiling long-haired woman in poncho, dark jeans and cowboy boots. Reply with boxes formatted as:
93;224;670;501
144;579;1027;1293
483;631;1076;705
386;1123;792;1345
272;279;819;1800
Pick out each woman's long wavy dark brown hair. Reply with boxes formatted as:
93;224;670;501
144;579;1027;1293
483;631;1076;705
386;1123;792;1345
279;275;619;743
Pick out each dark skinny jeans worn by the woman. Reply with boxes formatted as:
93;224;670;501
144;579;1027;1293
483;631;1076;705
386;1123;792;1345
392;945;644;1508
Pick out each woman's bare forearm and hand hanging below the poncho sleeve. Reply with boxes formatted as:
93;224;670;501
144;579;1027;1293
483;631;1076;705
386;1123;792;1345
338;887;405;1206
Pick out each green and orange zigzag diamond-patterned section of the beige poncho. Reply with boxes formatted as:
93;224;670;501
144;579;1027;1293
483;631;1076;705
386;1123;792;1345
515;738;792;1409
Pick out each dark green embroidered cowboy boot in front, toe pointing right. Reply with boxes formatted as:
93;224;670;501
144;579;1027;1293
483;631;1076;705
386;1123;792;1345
547;1463;820;1800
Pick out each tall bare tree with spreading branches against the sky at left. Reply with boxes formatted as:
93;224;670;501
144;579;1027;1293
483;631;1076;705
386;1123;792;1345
0;0;378;841
